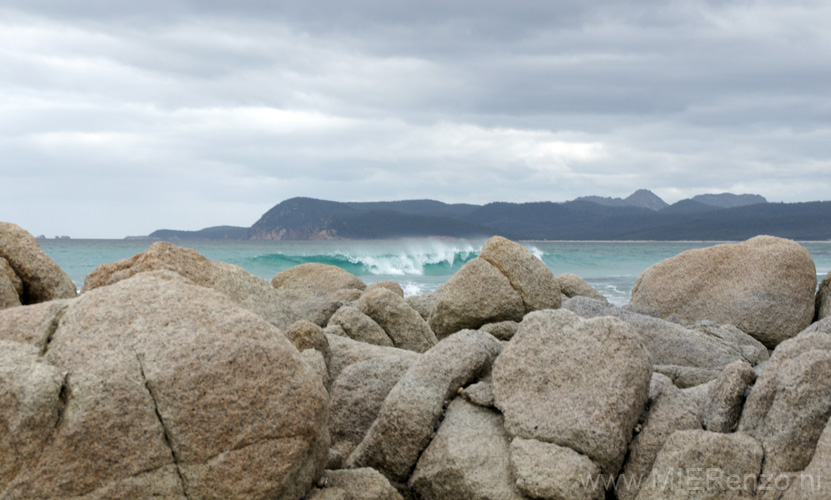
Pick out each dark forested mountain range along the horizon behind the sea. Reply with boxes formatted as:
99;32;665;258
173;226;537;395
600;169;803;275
143;190;831;240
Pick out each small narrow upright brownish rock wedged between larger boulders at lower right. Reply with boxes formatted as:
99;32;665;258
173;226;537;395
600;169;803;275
704;361;756;433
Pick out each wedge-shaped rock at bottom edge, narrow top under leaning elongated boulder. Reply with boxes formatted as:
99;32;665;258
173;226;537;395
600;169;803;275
409;398;523;500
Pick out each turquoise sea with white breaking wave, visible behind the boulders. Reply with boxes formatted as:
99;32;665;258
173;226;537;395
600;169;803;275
39;239;831;305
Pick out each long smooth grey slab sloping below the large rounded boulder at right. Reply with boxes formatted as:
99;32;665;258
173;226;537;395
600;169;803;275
562;297;767;371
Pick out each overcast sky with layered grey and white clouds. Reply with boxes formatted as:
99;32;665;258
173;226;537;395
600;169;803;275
0;0;831;238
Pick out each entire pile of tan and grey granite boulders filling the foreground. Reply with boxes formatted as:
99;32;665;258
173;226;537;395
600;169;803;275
0;224;831;500
